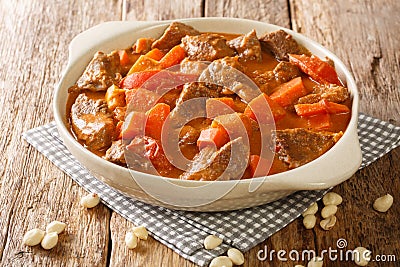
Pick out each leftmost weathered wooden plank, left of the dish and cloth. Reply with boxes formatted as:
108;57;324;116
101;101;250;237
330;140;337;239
0;0;122;266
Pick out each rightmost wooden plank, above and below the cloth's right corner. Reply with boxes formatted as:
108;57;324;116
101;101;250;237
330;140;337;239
290;0;400;266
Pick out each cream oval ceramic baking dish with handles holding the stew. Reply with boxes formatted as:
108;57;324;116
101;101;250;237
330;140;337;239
53;18;361;211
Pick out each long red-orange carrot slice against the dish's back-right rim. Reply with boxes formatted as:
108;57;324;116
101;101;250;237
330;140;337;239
289;54;342;85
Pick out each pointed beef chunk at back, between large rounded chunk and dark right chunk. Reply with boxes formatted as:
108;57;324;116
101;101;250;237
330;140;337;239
227;30;262;61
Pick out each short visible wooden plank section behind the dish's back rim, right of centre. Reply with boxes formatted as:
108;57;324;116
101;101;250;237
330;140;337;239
205;0;291;28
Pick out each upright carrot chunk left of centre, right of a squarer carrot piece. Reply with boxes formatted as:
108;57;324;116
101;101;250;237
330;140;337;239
145;103;171;140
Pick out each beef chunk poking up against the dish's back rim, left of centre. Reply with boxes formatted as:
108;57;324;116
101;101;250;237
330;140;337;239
152;21;200;50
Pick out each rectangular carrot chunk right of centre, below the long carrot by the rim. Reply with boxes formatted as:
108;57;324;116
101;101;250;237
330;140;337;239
270;77;308;107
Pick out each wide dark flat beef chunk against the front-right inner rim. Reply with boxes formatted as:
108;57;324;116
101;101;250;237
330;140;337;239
274;128;342;169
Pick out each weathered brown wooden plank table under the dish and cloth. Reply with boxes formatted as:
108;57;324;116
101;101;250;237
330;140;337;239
0;0;400;266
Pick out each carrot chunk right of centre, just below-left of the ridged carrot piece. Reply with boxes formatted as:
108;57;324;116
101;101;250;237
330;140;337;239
244;93;286;123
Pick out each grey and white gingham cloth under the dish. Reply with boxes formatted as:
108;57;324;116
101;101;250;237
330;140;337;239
23;114;400;266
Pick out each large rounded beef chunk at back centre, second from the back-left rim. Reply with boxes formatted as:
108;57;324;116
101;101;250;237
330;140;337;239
182;33;235;61
